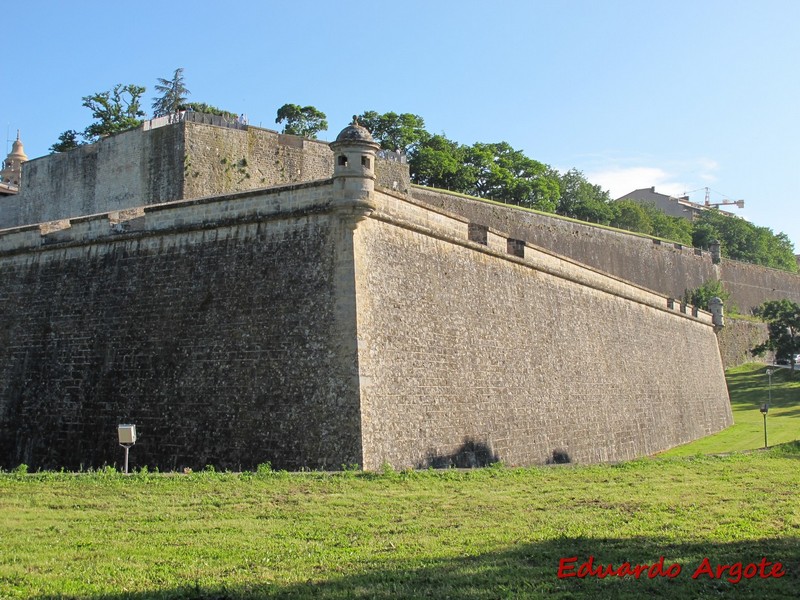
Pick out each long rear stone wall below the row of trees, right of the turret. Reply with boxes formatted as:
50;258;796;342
412;187;800;312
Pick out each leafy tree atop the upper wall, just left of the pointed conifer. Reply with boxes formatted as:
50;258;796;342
83;83;145;142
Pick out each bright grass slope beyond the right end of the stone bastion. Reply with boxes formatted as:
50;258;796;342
662;363;800;456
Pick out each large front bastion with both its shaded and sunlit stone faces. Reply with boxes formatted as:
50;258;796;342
0;179;731;469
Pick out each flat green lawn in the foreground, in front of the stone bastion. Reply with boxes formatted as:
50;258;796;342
0;369;800;600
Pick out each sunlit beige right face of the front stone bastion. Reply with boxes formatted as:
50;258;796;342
355;192;732;468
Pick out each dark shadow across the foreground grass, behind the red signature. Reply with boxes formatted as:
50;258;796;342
31;538;800;600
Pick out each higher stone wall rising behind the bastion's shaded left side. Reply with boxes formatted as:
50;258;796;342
0;121;410;229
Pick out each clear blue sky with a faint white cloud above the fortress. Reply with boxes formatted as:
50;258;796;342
6;0;800;246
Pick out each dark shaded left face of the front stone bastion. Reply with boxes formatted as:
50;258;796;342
0;184;361;469
